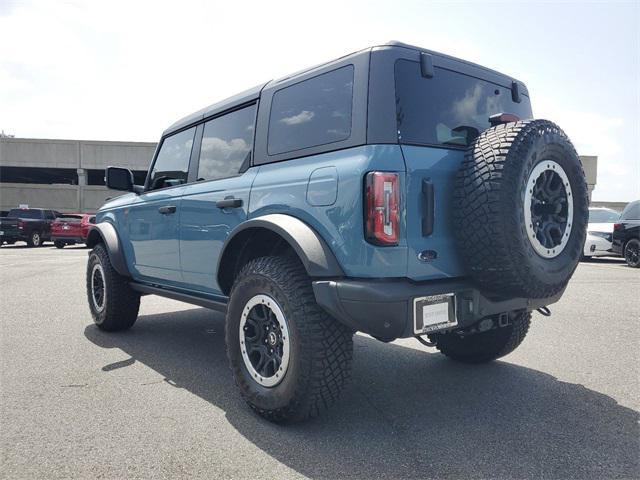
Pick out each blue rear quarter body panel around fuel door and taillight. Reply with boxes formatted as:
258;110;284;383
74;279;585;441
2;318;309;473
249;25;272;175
249;145;407;278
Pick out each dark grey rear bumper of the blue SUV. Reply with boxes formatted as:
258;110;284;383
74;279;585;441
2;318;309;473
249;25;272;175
313;279;563;340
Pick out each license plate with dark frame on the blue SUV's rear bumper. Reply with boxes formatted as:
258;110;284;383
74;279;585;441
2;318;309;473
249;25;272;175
413;293;458;335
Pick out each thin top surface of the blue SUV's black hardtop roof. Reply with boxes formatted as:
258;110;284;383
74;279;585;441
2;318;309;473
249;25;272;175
162;40;528;136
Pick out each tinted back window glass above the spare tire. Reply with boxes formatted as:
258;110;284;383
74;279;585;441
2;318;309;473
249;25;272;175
395;60;532;147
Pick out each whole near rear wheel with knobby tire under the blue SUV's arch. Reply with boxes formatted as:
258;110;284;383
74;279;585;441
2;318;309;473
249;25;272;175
226;256;353;423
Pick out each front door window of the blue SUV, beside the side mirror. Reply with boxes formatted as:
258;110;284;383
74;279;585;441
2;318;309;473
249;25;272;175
149;127;196;190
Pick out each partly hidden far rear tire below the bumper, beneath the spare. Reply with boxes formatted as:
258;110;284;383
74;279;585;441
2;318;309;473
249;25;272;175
429;312;531;363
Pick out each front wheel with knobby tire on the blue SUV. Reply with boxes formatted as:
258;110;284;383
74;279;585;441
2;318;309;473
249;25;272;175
87;243;140;332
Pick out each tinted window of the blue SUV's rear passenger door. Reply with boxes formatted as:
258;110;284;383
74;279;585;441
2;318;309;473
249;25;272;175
197;105;256;181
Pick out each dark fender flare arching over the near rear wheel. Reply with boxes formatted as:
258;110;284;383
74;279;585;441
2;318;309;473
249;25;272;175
216;213;344;292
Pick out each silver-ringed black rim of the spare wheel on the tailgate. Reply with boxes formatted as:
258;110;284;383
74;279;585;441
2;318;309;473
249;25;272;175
524;160;573;258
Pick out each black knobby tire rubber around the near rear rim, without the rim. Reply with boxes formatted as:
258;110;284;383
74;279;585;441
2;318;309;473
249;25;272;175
227;256;353;423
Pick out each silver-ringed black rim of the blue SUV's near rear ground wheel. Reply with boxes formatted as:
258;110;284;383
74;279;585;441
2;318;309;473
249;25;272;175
239;294;291;387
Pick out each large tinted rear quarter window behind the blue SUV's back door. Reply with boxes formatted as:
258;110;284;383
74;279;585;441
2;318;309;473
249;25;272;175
268;65;353;155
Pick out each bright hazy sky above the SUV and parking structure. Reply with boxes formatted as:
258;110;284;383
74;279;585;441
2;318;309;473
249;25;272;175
0;0;640;201
